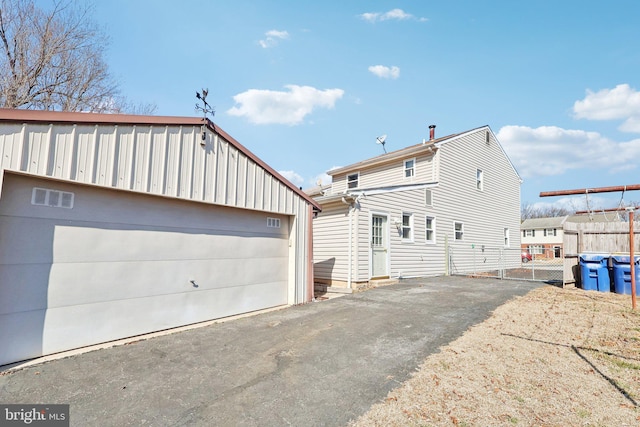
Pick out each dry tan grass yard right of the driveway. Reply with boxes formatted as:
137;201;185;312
351;286;640;427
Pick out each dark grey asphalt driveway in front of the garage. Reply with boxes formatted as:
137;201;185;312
0;277;543;426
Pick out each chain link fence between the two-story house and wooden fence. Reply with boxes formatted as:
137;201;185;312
449;246;563;283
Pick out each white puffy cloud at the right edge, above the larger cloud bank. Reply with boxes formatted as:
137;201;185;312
573;83;640;133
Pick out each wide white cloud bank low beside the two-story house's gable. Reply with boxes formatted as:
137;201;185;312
497;126;640;178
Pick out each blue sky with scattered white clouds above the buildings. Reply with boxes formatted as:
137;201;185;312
87;0;640;213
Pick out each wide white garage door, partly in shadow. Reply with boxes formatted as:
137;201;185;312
0;174;289;365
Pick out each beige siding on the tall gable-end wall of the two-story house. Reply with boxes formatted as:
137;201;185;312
433;128;520;272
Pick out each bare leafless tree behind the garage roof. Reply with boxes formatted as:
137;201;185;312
0;0;154;112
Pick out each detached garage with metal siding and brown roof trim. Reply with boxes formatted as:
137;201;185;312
0;109;320;365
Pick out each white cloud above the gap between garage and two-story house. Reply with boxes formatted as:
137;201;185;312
227;85;344;126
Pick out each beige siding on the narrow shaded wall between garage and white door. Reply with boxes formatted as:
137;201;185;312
313;201;353;282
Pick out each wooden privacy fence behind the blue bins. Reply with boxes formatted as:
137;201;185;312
562;221;640;286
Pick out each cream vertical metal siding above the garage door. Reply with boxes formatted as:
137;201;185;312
0;124;310;214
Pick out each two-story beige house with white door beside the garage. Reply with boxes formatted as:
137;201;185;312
307;126;521;287
